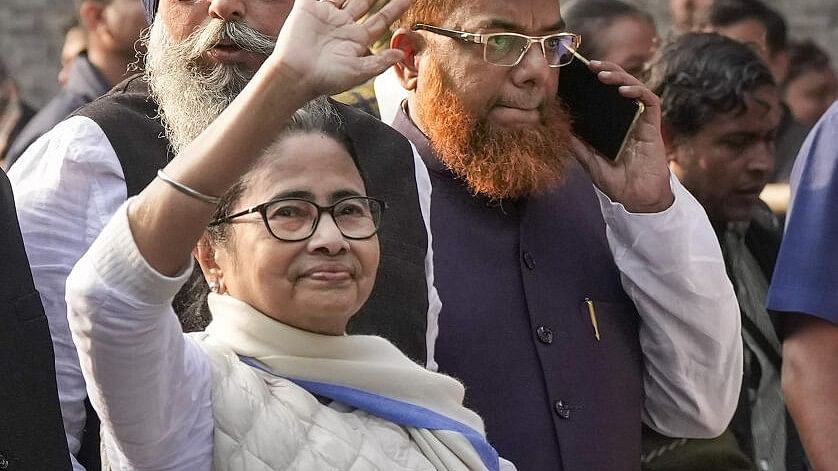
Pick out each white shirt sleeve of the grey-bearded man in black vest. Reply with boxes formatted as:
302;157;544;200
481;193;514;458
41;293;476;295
9;116;126;471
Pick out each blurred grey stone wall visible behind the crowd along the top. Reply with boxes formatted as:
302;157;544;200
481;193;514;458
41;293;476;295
0;0;838;106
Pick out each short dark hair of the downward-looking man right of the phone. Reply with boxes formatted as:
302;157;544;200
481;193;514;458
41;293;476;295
647;33;775;139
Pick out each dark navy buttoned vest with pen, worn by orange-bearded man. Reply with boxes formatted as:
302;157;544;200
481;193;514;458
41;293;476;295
394;112;643;471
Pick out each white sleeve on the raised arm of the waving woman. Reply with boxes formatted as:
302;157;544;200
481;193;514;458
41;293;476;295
67;200;213;470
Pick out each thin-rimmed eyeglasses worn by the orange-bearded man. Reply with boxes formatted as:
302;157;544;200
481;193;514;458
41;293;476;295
412;23;582;67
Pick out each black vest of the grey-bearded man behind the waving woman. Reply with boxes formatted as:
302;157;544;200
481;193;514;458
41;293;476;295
76;75;428;469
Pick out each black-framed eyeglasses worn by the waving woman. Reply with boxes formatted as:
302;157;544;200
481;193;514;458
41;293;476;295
209;196;387;242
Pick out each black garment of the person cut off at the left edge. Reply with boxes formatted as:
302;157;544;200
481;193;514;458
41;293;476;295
0;171;71;471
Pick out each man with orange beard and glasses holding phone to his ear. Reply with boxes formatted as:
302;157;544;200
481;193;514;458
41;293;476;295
391;0;742;471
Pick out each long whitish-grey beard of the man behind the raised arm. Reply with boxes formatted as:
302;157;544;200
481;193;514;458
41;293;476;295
145;19;276;155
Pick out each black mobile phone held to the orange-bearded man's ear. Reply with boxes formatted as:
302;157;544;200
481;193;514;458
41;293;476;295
559;52;645;160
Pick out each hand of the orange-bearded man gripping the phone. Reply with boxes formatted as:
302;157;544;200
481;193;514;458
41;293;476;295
572;61;674;213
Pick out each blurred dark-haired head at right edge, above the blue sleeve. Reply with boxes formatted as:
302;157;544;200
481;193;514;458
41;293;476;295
783;40;838;126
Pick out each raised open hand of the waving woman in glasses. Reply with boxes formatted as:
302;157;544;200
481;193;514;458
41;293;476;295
268;0;410;97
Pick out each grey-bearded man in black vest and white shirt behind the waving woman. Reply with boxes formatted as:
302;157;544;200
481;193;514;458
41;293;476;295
9;0;439;470
